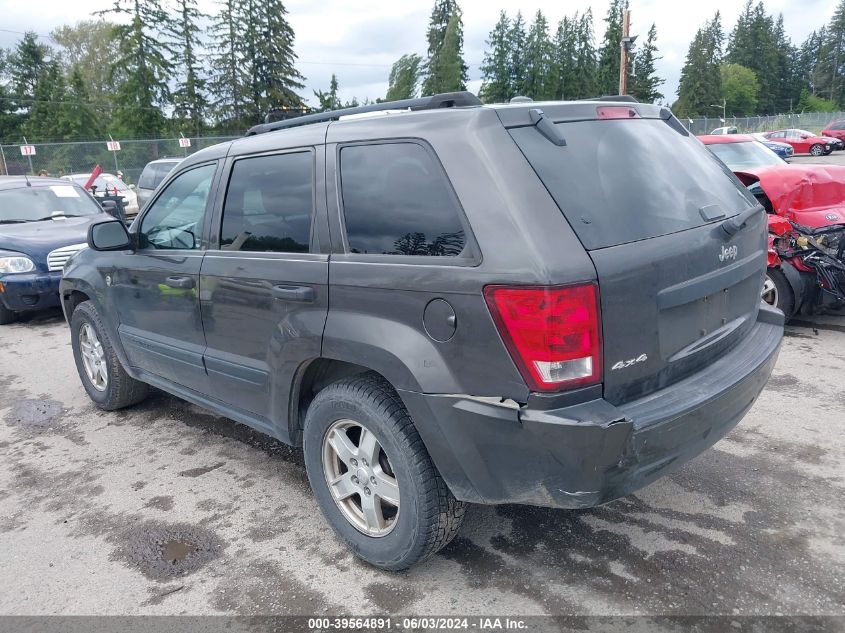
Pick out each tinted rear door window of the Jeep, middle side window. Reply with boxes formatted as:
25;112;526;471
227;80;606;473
220;152;314;253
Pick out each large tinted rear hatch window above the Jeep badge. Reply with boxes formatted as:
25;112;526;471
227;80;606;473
509;117;756;250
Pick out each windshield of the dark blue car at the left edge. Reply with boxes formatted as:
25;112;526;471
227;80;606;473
0;185;100;223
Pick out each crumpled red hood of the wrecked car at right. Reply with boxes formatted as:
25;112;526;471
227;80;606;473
736;165;845;228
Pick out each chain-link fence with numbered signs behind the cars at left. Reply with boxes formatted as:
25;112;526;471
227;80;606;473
0;136;238;183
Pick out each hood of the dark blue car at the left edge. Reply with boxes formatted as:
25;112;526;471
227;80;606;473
0;213;103;270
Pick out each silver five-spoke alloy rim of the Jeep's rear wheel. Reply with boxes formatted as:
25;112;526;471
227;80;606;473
322;420;399;538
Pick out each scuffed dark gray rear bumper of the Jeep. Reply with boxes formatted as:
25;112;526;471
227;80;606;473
401;307;783;508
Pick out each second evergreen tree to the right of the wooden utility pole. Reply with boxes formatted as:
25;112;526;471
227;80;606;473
672;11;724;117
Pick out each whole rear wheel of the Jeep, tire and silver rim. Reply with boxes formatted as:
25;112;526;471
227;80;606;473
304;374;465;571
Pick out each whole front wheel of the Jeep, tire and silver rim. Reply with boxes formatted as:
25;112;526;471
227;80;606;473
70;301;149;411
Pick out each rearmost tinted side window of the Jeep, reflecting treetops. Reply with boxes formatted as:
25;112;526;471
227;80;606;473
340;143;466;257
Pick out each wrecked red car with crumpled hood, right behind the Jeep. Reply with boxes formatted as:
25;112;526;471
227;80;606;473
698;134;845;318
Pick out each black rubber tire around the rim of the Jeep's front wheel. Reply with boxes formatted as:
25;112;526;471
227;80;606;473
70;301;150;411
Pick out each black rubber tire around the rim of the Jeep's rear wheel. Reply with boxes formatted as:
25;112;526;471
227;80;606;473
303;373;465;571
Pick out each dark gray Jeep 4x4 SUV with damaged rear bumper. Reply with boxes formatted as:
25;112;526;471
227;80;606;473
61;93;783;570
